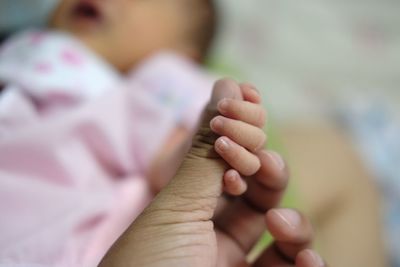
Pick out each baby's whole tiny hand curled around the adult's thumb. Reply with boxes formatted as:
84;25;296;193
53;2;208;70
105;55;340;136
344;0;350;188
210;84;267;195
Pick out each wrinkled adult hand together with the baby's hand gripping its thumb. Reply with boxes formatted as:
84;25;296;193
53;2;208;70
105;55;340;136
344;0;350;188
100;80;325;267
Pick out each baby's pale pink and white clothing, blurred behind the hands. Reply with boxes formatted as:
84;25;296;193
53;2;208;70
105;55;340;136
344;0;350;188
0;31;213;267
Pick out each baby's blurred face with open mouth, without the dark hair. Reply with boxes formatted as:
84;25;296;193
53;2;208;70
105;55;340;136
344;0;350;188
50;0;188;71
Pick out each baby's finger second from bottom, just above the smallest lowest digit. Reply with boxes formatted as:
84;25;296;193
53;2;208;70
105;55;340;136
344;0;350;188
214;136;260;176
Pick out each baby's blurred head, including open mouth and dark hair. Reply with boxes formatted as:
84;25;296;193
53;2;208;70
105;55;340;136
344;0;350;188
50;0;217;72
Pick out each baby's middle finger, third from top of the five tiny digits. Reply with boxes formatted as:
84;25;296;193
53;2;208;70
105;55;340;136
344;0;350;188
210;116;267;152
